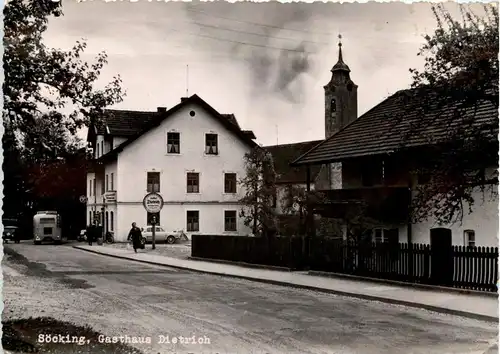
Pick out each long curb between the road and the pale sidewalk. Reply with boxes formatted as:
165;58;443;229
73;246;499;323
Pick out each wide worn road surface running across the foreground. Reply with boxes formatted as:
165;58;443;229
3;243;498;354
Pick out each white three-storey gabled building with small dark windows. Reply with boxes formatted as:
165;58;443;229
87;95;256;241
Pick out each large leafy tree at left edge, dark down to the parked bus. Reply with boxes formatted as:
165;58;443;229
2;0;125;218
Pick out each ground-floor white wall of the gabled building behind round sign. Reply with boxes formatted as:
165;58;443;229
115;203;251;241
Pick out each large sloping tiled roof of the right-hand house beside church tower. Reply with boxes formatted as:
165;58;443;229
293;90;498;166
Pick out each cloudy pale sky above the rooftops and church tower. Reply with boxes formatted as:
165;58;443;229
45;0;488;145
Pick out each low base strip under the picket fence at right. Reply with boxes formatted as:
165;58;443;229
307;270;498;299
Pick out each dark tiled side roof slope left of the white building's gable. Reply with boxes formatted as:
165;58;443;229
97;109;162;137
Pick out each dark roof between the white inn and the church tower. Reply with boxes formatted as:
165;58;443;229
264;140;323;183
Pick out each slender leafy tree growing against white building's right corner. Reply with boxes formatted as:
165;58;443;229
240;147;276;235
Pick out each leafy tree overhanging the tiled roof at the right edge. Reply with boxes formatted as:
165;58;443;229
403;5;499;224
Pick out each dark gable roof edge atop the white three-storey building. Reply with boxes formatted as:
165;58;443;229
98;95;258;161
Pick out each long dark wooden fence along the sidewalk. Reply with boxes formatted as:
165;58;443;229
192;235;498;292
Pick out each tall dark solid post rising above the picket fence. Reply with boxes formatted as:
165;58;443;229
430;228;453;286
